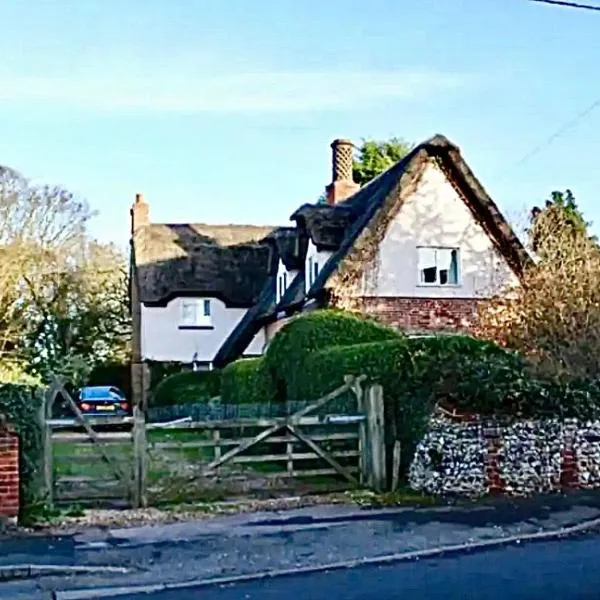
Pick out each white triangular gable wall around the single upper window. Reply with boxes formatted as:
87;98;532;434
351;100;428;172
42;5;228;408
363;162;519;298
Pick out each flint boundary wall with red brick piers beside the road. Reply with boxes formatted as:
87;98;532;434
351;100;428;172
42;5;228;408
409;416;600;496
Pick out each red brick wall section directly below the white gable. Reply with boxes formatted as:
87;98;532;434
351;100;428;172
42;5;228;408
363;296;477;332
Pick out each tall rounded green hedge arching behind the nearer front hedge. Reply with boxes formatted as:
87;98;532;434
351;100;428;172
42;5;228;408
265;310;402;401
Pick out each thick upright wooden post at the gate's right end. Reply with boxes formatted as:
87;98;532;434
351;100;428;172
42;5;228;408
361;385;387;492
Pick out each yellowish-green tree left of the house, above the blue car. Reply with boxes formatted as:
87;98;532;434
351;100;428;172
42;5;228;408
21;241;130;383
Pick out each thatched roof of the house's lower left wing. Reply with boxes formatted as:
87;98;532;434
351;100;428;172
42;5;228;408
133;223;273;307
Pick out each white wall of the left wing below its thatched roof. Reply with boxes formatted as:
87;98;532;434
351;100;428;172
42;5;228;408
141;298;265;363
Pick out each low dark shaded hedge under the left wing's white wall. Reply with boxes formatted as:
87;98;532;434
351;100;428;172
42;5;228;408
150;370;221;406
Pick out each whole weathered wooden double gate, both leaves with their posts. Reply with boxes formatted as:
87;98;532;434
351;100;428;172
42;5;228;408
41;376;386;507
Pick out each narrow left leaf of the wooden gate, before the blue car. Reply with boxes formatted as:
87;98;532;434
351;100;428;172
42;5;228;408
41;378;135;506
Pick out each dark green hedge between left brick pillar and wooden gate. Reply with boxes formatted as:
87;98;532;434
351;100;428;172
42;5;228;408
0;384;44;504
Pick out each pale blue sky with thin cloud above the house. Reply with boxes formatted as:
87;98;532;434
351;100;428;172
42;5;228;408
0;0;600;248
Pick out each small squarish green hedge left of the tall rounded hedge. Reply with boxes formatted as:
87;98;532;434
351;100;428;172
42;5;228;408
221;358;277;404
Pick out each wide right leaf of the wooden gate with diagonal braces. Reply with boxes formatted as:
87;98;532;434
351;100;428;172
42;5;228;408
139;377;385;504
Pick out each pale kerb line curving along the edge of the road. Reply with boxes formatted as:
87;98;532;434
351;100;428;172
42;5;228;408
52;518;600;600
